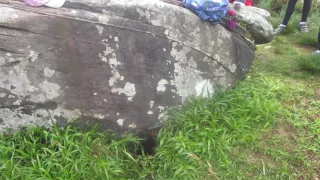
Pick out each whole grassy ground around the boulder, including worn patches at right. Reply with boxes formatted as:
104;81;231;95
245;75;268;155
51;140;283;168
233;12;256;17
0;3;320;180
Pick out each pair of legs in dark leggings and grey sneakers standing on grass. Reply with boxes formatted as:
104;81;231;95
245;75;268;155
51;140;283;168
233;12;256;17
273;0;312;35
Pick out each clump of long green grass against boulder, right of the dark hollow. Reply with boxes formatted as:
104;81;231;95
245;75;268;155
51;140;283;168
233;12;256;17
156;74;282;179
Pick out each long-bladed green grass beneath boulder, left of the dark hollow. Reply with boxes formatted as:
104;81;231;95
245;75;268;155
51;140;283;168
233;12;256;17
0;126;148;180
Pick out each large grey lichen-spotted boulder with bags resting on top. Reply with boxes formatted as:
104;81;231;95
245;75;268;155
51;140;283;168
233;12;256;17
0;0;254;130
